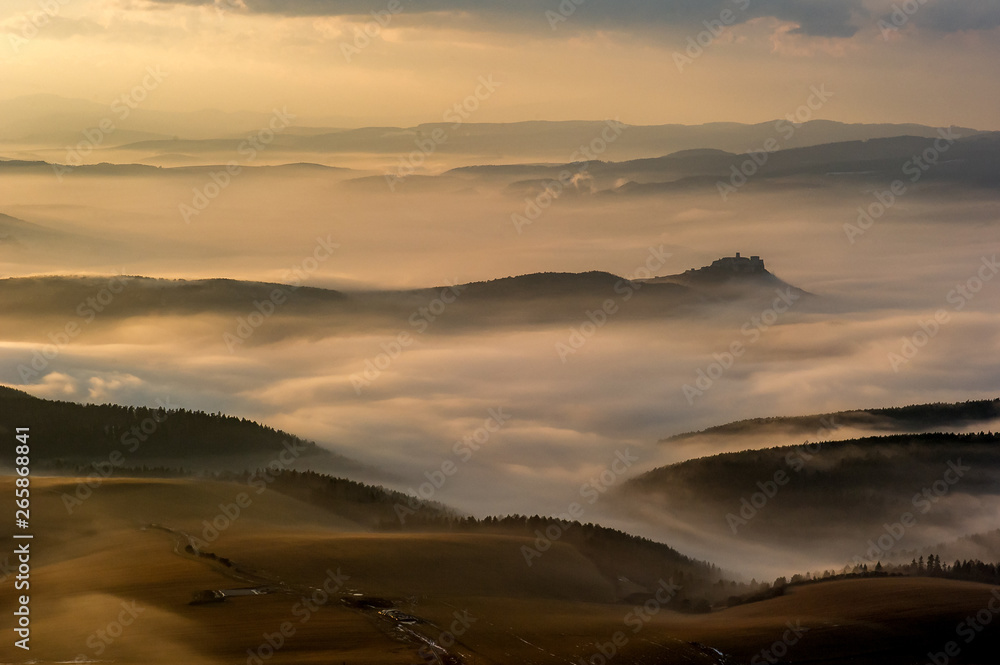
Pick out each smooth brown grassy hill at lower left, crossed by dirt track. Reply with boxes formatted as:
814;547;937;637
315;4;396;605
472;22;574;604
0;474;732;663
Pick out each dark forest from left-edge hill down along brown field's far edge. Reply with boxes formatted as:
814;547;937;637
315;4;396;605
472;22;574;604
0;387;736;609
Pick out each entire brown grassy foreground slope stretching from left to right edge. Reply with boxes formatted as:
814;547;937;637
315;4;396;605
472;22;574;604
0;478;995;665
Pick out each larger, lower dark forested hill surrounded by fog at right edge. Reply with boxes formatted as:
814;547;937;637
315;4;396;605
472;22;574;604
615;433;1000;557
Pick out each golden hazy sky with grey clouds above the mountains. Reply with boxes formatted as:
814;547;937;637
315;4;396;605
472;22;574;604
0;0;1000;129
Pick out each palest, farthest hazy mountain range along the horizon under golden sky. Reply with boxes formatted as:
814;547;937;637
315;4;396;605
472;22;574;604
0;95;979;161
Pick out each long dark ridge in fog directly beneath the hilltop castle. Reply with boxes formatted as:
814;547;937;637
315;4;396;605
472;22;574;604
0;262;804;343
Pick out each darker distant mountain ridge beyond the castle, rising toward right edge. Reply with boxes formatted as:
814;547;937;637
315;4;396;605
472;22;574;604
7;130;1000;200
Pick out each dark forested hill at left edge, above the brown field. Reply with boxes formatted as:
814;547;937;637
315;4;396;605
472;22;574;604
0;386;370;472
